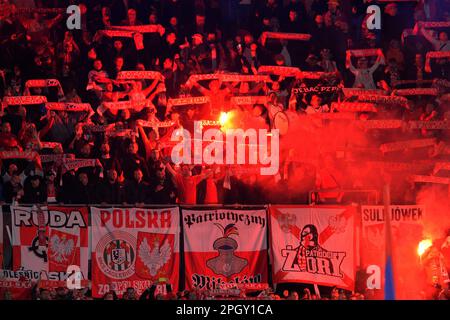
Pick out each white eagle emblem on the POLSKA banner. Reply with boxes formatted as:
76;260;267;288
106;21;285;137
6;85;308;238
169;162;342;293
138;238;172;277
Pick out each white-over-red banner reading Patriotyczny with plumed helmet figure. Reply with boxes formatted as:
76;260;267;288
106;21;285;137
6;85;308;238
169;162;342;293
182;209;268;290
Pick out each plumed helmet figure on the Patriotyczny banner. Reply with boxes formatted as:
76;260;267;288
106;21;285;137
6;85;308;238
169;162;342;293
206;223;248;277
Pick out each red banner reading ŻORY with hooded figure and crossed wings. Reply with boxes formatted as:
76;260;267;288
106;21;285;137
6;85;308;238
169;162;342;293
270;206;356;290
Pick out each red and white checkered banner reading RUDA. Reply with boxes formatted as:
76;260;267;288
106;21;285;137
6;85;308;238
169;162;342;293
11;206;89;286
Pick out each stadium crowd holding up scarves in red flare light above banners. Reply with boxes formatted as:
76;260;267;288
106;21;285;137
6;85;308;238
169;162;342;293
0;0;450;300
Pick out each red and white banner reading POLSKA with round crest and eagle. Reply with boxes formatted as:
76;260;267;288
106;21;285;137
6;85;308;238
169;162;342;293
91;207;180;298
